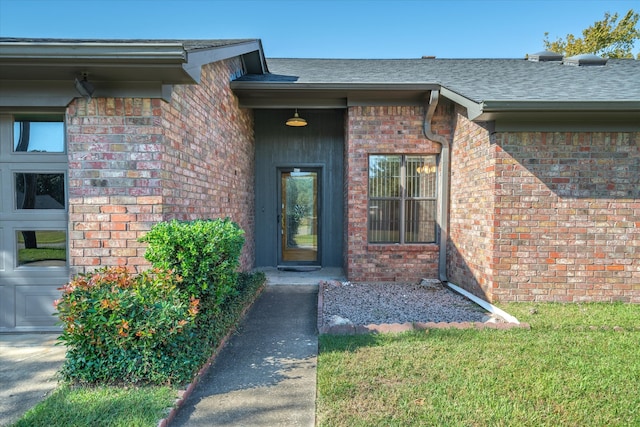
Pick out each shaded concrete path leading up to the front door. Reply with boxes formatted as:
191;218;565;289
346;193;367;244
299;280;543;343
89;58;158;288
171;284;318;427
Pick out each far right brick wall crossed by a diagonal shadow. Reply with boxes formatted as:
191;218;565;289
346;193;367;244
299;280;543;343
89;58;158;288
493;133;640;303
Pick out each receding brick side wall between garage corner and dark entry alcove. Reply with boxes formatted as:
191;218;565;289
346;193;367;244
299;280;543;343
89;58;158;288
162;61;255;269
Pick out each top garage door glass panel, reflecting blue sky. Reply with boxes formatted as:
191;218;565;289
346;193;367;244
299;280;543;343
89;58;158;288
13;118;64;153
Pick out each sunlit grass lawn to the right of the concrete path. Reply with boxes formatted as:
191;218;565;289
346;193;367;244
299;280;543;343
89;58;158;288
317;304;640;427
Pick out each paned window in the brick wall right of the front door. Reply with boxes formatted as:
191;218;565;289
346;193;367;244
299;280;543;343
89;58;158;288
369;155;437;243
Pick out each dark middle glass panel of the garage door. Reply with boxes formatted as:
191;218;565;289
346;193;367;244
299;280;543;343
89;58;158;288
15;173;66;209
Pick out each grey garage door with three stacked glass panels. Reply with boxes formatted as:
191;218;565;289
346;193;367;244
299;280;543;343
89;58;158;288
0;112;69;331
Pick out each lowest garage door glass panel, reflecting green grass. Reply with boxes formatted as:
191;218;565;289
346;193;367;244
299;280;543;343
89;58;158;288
16;230;67;267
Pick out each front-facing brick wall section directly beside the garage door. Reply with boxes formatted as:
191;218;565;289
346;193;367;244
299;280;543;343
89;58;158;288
67;98;164;273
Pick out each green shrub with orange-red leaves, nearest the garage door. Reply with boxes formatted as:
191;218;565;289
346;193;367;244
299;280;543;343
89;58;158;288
56;267;199;384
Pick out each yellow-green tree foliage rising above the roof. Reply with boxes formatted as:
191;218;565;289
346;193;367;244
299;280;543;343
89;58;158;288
543;9;640;58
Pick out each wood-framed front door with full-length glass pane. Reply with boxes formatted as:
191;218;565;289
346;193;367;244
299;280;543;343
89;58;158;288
278;168;320;266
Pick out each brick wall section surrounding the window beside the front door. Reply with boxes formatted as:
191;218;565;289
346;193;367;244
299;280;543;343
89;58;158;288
345;107;451;282
